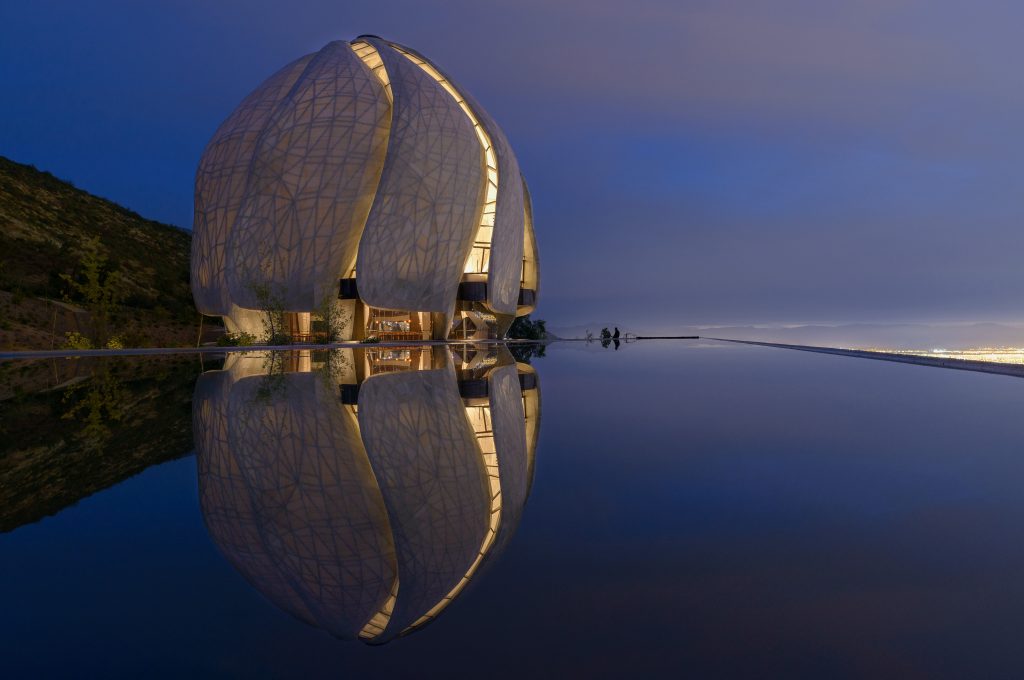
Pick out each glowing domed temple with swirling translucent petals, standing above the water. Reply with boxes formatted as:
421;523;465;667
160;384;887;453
191;36;539;340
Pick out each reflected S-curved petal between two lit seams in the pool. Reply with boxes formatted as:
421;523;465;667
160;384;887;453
359;366;490;641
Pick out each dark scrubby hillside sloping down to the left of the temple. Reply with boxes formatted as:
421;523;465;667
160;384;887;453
0;157;197;349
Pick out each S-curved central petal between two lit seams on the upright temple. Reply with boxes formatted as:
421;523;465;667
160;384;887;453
356;38;483;313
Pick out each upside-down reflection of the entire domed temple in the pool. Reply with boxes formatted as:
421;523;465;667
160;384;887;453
193;345;540;643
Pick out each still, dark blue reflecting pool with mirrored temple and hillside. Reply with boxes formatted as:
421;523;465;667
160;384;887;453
0;341;1024;678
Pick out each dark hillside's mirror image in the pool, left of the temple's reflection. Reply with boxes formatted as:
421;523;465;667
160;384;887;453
0;357;200;532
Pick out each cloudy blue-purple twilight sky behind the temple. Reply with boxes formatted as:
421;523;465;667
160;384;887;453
0;0;1024;330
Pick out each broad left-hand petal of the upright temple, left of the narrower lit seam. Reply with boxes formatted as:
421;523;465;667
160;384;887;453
227;42;391;311
